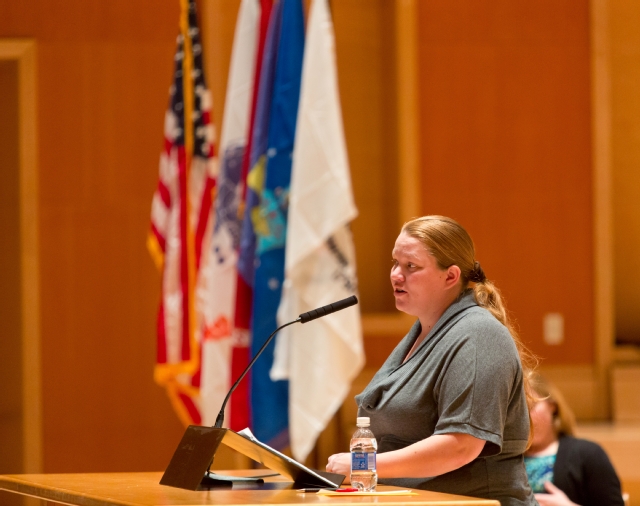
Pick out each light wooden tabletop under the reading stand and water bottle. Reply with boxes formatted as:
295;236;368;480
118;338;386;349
0;470;500;506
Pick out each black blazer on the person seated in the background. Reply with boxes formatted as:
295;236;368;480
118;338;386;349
553;436;624;506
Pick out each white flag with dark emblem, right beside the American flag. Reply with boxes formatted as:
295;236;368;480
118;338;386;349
198;0;260;425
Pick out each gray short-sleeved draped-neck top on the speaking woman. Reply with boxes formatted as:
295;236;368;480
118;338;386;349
356;290;537;506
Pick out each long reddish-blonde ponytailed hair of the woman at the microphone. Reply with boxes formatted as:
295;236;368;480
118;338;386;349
402;215;538;441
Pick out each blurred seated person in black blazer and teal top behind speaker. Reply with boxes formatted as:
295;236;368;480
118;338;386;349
524;376;624;506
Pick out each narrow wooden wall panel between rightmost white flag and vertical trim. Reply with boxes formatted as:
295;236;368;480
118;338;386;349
331;0;399;312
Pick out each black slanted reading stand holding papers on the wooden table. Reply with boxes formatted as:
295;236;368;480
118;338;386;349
160;425;345;490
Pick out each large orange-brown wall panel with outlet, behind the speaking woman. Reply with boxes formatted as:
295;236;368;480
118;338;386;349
419;0;594;364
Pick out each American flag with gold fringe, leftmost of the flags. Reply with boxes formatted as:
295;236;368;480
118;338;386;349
147;0;217;425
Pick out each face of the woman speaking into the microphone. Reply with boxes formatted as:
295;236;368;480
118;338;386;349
391;233;450;317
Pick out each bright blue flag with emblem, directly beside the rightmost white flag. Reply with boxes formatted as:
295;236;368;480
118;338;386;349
251;0;304;448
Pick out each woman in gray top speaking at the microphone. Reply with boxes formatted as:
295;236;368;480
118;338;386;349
327;216;537;506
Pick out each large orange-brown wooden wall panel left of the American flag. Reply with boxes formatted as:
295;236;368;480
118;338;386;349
0;0;182;472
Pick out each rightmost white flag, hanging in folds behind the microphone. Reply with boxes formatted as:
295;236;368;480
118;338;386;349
271;0;364;461
